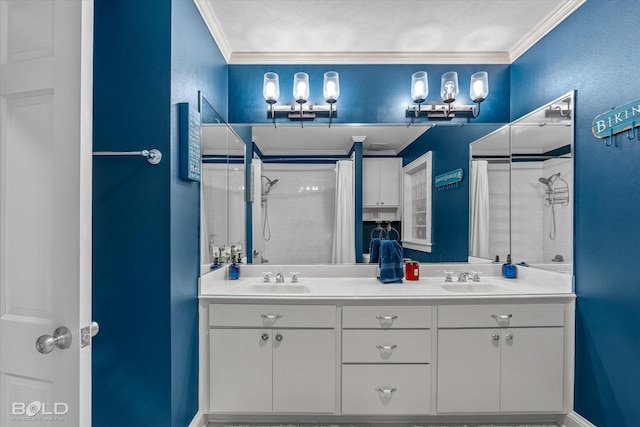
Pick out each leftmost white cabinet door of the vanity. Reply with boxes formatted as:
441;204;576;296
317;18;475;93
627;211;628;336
209;329;273;412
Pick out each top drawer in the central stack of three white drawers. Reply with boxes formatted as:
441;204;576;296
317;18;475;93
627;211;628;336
342;305;431;329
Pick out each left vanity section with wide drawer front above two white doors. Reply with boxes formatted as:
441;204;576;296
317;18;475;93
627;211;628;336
209;304;336;413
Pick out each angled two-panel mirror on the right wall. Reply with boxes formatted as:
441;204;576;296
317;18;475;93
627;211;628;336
469;92;574;273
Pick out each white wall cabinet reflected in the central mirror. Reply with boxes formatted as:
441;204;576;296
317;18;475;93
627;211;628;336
362;157;402;208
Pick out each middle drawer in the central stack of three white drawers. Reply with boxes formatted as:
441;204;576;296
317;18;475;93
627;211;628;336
342;329;431;363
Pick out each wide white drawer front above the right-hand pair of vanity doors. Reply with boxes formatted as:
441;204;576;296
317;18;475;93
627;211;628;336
438;304;564;328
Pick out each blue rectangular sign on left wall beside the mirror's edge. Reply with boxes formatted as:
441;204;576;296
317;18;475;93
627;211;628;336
178;102;202;181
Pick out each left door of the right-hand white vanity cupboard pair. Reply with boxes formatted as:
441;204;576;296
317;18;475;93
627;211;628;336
437;329;501;412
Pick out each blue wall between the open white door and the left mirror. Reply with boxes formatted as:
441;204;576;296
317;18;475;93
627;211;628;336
93;0;228;427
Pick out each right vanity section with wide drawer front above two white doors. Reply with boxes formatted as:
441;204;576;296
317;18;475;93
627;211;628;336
437;304;565;413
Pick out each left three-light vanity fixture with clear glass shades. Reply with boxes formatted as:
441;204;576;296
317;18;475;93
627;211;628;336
262;71;340;127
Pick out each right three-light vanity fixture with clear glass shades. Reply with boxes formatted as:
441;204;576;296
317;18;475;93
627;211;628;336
407;71;489;119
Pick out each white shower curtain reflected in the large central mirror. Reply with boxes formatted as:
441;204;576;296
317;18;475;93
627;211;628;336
331;160;356;264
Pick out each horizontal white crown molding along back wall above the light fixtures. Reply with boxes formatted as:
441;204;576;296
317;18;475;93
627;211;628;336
228;52;509;65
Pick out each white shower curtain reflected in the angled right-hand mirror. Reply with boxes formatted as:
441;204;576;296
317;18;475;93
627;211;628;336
469;160;491;258
